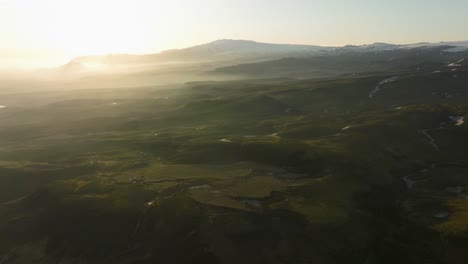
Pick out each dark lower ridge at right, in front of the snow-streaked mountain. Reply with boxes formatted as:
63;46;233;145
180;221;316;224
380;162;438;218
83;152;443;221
213;44;468;78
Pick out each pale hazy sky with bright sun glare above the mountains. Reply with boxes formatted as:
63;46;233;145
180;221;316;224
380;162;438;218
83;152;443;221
0;0;468;68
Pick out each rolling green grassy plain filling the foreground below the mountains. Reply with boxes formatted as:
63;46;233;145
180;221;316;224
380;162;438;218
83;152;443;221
0;56;468;263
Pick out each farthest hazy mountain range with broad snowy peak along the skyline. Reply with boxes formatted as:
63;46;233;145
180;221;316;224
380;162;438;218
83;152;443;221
68;39;468;64
